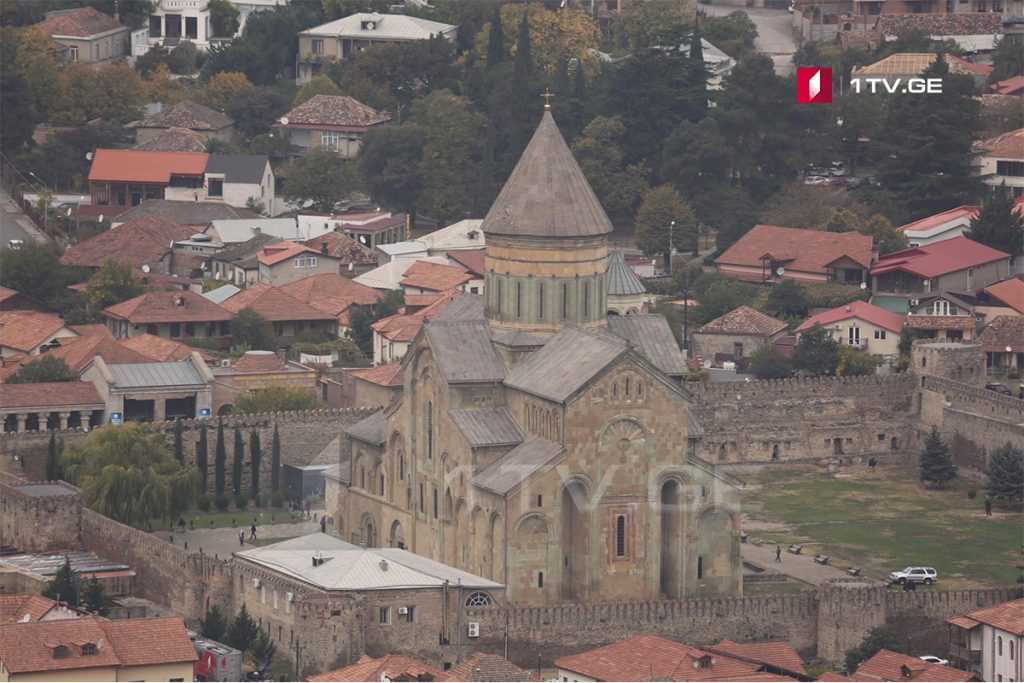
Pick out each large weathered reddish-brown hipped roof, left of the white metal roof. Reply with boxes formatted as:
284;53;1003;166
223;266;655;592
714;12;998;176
60;216;194;268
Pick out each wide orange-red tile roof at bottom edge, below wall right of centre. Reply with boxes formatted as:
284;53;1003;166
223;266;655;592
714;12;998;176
555;634;759;681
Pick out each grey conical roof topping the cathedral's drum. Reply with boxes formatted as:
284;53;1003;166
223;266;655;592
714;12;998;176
480;112;611;238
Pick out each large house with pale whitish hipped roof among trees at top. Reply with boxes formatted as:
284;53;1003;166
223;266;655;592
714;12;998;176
295;12;459;85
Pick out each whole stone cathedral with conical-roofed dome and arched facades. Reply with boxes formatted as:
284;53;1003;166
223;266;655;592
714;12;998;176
326;111;742;606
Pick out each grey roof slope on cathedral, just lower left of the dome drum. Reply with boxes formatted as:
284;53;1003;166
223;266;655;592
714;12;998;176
424;321;505;383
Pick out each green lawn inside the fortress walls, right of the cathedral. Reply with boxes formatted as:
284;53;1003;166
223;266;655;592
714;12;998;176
742;467;1024;588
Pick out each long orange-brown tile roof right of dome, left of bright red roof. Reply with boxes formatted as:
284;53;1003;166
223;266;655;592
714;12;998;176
715;225;871;279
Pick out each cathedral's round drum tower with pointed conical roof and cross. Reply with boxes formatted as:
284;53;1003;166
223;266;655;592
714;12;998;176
481;106;611;338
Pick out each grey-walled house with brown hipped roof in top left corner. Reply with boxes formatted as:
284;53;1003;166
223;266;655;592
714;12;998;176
35;7;131;67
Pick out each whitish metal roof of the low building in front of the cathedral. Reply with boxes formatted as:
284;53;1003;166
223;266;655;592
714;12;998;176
234;533;503;591
